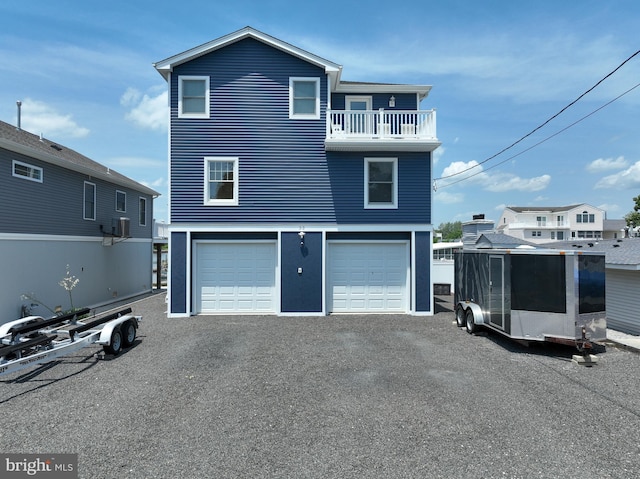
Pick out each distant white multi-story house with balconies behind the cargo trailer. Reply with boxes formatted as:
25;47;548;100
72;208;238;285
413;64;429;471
496;203;606;243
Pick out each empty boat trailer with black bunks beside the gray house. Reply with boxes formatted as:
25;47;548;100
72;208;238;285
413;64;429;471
0;308;142;376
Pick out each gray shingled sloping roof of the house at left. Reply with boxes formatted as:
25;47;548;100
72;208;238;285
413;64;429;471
0;121;160;196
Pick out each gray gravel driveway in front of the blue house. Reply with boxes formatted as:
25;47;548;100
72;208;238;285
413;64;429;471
0;295;640;479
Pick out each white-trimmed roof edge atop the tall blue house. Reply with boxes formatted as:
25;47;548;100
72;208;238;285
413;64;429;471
153;26;431;100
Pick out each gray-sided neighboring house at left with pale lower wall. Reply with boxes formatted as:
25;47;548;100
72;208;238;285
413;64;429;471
0;122;158;323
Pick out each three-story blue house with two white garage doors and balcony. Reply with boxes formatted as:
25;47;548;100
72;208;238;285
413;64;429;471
154;27;440;317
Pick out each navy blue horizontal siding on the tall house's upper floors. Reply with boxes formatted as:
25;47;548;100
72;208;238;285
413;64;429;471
170;39;431;224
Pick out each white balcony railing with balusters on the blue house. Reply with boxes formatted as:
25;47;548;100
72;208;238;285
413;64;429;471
327;109;437;141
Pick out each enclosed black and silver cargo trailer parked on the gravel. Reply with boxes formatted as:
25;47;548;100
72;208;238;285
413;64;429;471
454;249;607;350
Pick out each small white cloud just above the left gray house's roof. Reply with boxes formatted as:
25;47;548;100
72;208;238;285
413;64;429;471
20;98;89;138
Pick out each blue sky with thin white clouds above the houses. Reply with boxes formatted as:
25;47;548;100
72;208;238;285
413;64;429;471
0;0;640;226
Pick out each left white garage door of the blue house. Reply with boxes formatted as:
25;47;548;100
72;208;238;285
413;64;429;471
195;242;276;314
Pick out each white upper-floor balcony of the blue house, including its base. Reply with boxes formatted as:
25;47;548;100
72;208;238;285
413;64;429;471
325;109;440;152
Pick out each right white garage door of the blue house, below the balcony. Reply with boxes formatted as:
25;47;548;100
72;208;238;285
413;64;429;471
327;242;409;313
